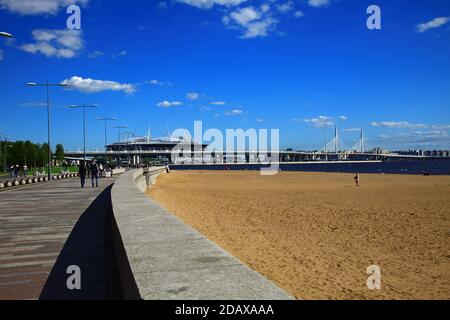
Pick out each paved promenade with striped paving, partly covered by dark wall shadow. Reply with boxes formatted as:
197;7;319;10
0;178;120;300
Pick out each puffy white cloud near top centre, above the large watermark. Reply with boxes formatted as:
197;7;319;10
222;4;278;39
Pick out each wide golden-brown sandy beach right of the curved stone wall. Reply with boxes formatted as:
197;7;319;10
148;171;450;299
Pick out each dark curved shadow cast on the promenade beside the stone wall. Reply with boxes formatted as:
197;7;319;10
39;186;123;300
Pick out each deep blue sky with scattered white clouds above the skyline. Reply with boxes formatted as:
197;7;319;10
0;0;450;149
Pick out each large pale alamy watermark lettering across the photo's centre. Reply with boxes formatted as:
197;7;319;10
171;121;280;175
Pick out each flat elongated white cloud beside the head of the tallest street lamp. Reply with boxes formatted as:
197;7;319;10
61;76;136;94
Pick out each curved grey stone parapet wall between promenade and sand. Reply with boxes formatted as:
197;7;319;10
111;167;293;300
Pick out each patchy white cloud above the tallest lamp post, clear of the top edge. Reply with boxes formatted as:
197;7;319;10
19;29;84;59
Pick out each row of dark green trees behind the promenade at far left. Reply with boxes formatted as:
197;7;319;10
0;141;64;169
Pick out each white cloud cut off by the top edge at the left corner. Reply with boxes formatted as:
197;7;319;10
0;0;89;15
